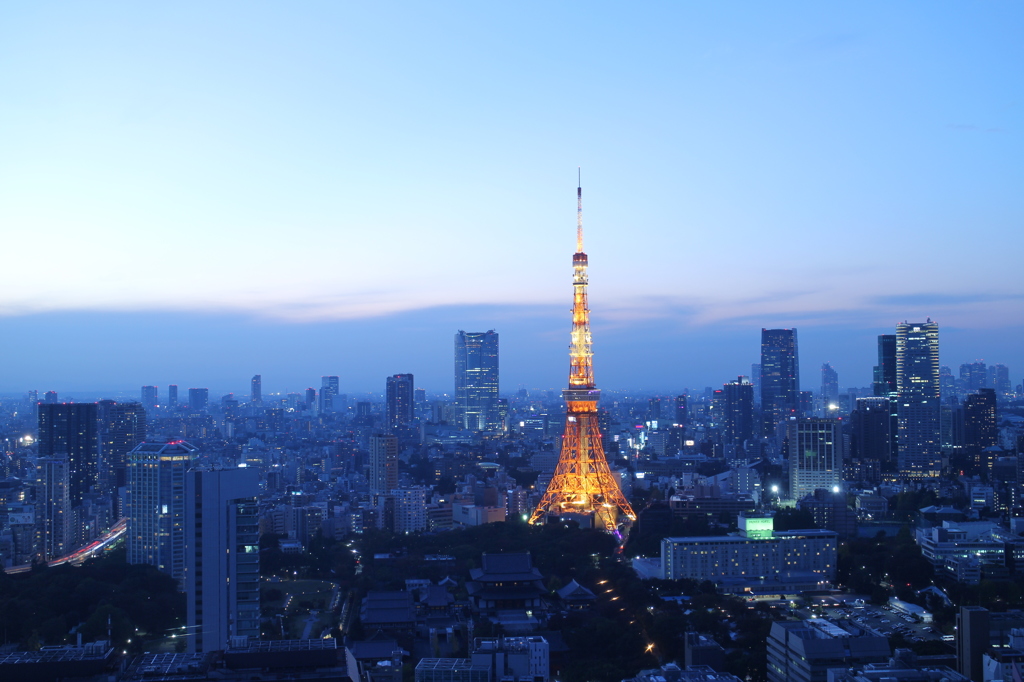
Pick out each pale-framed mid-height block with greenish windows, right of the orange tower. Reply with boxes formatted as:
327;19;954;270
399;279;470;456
786;419;843;500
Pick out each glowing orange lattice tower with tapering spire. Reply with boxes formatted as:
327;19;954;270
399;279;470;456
529;175;636;530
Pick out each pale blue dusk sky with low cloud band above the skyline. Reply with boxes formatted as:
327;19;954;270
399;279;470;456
0;1;1024;395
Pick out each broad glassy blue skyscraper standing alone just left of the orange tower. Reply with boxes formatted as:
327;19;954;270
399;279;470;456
455;330;500;431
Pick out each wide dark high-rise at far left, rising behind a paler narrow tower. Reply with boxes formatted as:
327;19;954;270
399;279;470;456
39;402;99;507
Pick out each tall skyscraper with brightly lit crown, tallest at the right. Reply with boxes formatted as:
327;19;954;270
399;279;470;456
896;319;942;479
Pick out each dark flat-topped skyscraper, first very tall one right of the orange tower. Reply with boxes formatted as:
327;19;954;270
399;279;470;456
761;329;800;436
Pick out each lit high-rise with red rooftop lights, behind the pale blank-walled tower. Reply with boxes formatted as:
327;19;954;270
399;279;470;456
125;440;197;580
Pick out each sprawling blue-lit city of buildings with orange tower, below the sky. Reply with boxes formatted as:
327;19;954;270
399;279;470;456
0;204;1024;682
